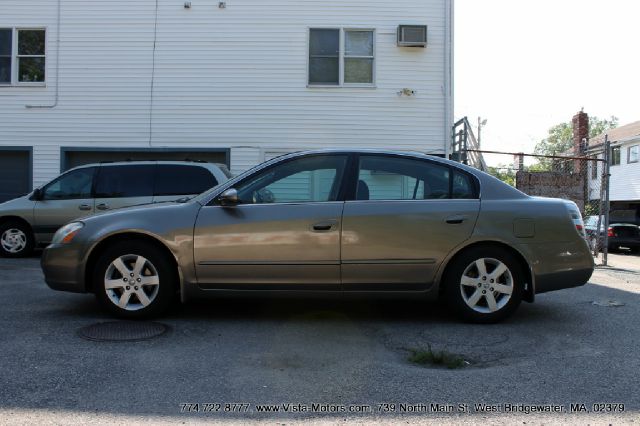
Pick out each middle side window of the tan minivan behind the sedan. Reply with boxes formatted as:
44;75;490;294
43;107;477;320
96;164;156;198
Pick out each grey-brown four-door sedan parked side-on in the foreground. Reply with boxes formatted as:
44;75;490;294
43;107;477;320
42;150;594;323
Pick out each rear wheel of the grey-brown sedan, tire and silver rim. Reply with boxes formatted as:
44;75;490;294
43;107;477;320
444;246;525;324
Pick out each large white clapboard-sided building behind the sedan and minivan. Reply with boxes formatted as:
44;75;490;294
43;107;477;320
0;0;453;203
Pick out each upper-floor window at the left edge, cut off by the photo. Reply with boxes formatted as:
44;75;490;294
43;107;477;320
0;28;46;85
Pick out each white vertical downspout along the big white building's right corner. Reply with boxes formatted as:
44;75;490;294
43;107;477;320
443;0;454;158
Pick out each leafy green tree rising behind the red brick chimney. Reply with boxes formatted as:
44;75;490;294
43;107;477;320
532;115;618;171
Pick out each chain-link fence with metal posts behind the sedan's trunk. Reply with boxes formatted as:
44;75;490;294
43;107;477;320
468;147;609;265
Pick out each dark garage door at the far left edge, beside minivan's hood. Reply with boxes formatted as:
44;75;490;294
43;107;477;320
0;149;31;203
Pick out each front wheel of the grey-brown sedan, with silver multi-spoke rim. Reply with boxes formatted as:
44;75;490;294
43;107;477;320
92;241;178;319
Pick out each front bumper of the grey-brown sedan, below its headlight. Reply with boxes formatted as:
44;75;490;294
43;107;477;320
40;244;87;293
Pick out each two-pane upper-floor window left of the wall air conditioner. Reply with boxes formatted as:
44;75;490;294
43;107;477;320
309;28;375;86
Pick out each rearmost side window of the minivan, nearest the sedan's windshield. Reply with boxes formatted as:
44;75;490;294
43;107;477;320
153;164;219;197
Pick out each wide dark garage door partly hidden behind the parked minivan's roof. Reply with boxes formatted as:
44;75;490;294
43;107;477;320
62;149;228;171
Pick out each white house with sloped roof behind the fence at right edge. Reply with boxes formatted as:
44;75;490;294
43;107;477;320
588;121;640;222
